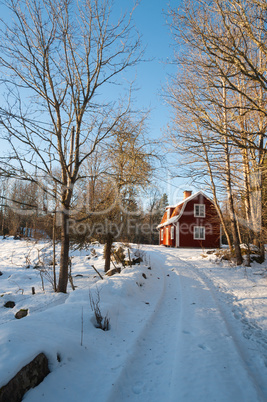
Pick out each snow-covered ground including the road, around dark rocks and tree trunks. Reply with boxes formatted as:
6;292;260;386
0;239;267;402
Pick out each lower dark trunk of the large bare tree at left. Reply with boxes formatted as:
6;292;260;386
57;208;70;293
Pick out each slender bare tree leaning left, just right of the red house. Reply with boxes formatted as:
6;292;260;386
167;60;242;264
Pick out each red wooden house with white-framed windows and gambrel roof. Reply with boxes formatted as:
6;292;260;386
158;191;221;248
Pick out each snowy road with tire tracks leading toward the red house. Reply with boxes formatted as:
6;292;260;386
109;249;266;402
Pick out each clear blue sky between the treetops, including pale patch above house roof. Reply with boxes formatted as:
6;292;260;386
130;0;195;204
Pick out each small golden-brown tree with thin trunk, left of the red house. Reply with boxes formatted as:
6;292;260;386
69;113;153;271
